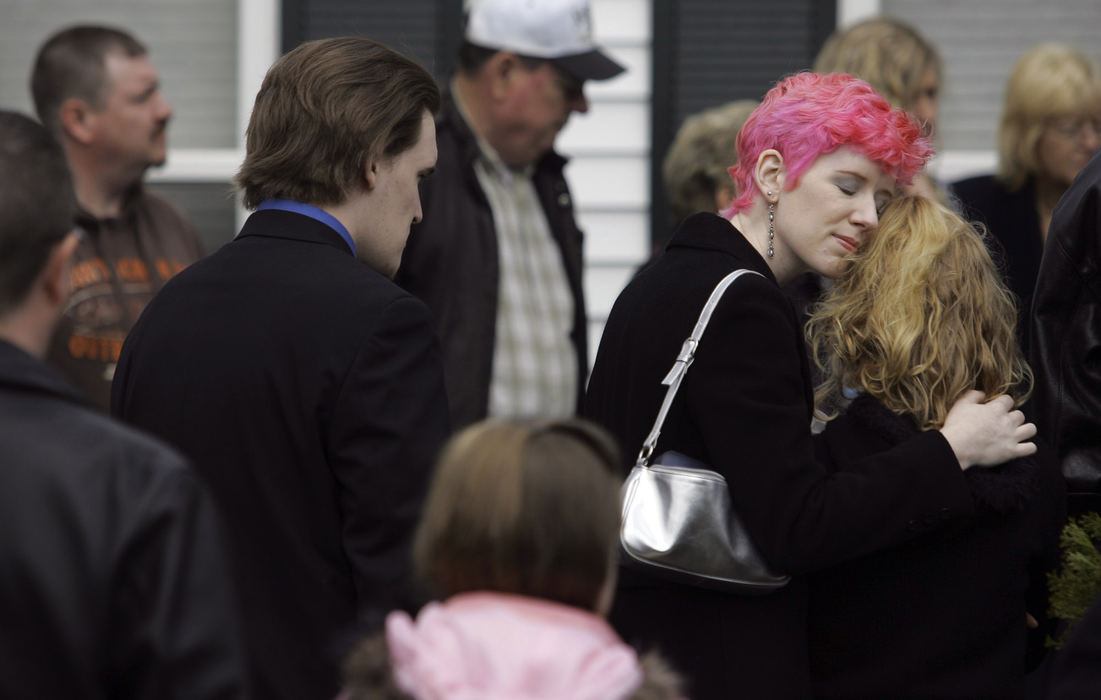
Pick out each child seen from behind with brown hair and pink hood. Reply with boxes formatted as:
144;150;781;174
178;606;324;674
330;419;680;700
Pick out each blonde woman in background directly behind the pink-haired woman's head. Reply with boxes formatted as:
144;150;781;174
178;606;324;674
814;15;945;201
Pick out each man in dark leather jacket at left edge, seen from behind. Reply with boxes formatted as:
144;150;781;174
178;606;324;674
0;111;244;700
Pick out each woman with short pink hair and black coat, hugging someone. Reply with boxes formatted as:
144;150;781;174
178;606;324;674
586;74;1035;700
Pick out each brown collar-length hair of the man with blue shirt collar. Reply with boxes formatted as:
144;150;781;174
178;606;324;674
237;36;439;209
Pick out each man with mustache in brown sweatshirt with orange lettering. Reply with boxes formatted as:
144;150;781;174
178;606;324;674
31;25;203;411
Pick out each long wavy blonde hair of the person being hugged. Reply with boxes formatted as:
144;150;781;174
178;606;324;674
807;196;1032;430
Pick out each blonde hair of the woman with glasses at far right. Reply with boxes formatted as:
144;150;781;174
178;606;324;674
998;42;1101;192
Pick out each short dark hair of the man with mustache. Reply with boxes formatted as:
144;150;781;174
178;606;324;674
31;24;146;134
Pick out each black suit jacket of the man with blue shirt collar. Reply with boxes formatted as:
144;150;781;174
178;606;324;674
112;210;448;700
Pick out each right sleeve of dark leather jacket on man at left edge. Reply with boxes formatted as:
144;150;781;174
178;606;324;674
109;457;246;700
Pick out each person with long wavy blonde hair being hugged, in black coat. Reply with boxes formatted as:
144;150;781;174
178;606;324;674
808;196;1066;698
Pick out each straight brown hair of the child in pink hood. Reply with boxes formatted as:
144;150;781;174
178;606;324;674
413;418;621;610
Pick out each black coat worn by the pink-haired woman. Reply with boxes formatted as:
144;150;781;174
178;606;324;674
586;214;972;700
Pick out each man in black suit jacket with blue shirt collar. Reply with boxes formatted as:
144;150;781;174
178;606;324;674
112;37;448;700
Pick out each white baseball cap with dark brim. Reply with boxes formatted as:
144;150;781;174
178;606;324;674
466;0;624;80
